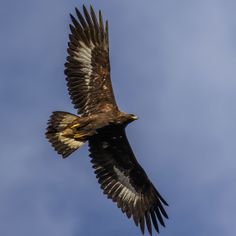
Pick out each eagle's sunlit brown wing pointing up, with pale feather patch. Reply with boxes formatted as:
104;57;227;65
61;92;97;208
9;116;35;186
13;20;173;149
65;6;117;114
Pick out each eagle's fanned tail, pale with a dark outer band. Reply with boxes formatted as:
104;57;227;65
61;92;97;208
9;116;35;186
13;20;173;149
45;111;84;158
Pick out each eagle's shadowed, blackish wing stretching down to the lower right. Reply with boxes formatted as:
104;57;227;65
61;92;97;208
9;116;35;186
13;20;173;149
89;126;168;235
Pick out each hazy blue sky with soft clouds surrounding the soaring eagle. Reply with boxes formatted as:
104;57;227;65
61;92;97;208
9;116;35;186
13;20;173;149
0;0;236;236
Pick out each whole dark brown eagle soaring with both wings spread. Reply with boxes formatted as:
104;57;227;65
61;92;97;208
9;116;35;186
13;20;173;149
45;6;168;235
